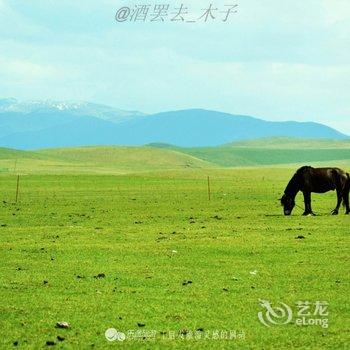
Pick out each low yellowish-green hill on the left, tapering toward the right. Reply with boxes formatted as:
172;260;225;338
0;146;214;174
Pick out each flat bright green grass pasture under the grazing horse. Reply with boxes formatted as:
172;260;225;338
0;168;350;349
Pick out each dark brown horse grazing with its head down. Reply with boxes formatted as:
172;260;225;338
281;166;350;215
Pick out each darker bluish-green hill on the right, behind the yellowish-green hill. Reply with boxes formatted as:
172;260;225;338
152;137;350;167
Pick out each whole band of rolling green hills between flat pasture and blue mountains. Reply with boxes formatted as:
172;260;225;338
0;138;350;174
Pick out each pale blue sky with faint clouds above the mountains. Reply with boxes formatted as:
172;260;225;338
0;0;350;134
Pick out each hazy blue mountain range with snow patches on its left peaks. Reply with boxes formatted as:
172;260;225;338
0;99;348;149
